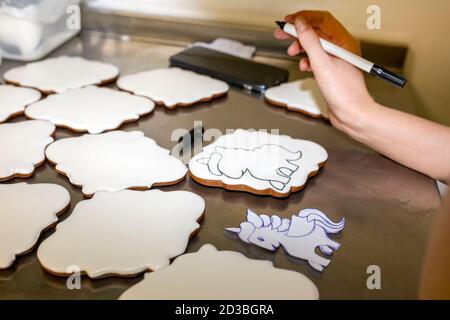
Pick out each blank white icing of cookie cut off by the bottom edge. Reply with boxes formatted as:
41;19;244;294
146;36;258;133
120;244;319;301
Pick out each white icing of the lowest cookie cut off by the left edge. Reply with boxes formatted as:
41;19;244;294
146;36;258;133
0;182;70;269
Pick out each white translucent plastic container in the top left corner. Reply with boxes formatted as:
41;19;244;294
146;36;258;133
0;0;81;61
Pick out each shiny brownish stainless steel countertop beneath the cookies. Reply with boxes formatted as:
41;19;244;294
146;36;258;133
0;28;440;299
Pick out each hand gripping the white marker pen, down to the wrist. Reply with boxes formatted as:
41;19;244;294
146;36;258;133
275;11;376;132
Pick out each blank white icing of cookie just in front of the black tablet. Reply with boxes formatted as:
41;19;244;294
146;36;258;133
117;68;229;108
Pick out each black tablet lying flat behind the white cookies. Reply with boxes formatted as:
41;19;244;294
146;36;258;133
170;47;289;92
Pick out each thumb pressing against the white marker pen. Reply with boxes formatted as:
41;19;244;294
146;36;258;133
295;17;332;68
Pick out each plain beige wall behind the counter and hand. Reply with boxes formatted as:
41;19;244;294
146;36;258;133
91;0;450;125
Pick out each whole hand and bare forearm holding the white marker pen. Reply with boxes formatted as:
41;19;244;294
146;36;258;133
276;11;450;183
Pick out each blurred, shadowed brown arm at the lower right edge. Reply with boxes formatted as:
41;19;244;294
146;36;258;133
419;192;450;299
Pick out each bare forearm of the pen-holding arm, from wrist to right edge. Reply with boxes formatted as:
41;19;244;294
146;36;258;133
342;102;450;183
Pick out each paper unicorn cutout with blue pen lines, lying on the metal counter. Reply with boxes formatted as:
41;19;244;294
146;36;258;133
226;209;345;271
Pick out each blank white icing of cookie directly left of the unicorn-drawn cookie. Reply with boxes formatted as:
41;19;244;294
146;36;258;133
46;131;187;196
